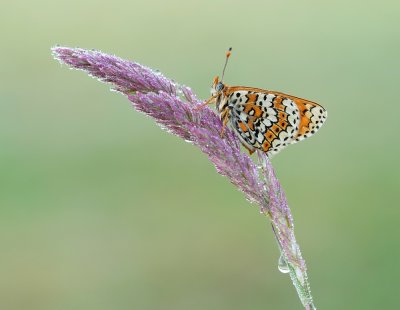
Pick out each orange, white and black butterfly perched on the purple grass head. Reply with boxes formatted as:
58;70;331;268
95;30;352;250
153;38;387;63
199;48;327;156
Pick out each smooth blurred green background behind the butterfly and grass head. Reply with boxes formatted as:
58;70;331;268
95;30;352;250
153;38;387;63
0;0;400;310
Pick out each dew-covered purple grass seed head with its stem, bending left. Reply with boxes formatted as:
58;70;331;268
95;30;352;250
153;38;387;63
52;47;316;310
